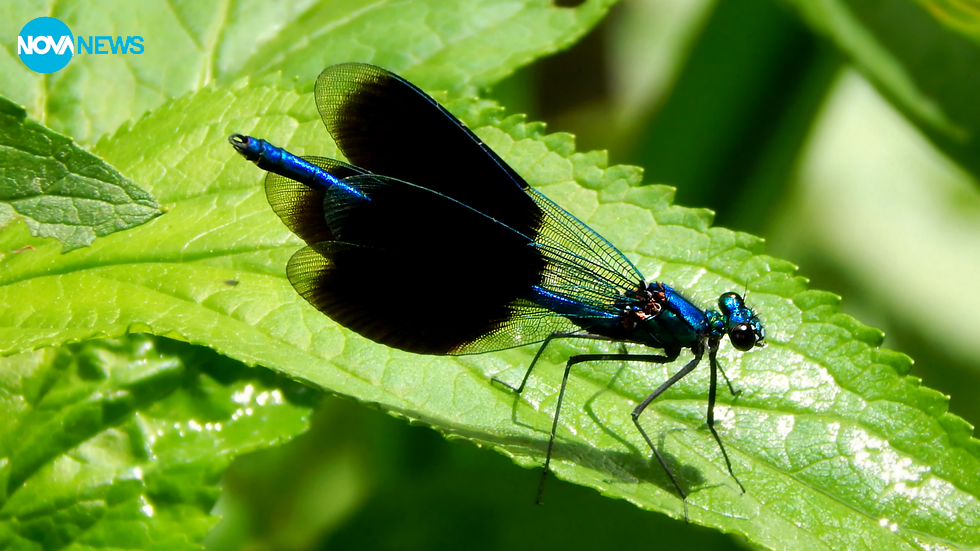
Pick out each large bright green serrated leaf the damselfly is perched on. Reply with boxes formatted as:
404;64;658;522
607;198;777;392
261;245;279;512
0;83;980;549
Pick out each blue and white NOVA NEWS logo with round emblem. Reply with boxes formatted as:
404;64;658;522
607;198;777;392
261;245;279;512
17;17;143;74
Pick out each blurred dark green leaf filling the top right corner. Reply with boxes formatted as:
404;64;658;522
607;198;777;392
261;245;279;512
791;0;980;178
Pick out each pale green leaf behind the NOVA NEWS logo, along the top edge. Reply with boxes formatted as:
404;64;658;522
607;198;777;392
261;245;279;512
0;0;614;144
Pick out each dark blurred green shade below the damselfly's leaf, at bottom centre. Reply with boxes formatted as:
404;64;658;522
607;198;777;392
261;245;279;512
214;399;744;551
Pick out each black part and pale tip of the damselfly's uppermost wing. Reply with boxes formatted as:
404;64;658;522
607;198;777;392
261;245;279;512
316;63;541;235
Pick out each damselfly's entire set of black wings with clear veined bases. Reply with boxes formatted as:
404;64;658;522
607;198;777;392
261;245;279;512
280;63;643;354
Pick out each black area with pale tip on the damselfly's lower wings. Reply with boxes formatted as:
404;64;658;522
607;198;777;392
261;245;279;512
286;175;556;354
